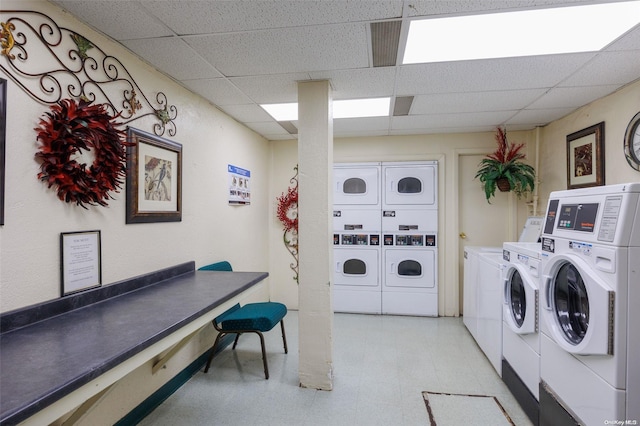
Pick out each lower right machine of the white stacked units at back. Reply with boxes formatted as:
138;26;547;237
382;231;438;317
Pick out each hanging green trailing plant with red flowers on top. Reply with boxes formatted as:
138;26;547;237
475;127;535;203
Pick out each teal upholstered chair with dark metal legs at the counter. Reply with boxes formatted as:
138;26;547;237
198;261;289;379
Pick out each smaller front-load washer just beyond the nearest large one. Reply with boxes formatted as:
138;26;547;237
502;242;542;424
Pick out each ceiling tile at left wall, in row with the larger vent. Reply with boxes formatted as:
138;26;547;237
123;37;222;80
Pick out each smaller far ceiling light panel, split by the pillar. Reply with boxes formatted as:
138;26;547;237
260;98;391;121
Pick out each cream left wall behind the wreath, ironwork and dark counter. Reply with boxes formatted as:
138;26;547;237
0;0;271;425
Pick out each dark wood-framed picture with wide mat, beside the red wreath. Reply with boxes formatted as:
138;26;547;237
126;127;182;223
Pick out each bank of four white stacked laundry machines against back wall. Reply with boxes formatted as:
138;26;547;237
333;161;438;316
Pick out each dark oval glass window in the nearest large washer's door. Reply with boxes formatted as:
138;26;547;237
553;263;589;345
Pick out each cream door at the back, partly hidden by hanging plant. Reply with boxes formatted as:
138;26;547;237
458;155;510;313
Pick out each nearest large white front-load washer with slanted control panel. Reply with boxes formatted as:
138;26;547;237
540;183;640;426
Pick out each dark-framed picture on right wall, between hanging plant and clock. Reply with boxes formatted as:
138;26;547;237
567;121;604;189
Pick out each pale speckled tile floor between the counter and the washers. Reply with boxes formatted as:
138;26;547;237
140;311;531;426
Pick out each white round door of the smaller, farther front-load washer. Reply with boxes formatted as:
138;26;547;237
502;264;538;334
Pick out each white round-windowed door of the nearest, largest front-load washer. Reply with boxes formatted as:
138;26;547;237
541;255;614;355
